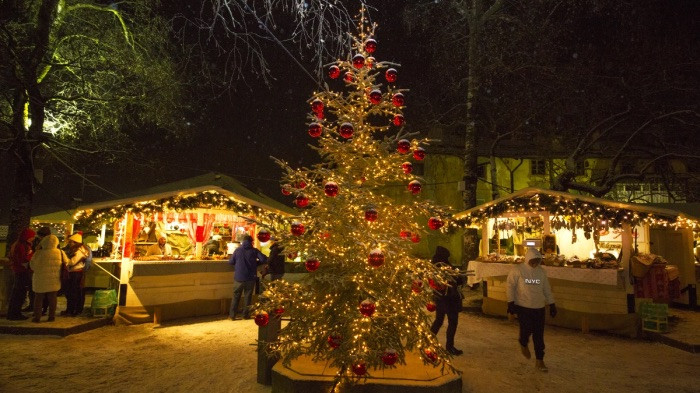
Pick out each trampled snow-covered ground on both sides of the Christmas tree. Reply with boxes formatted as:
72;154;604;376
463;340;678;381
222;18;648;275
0;313;700;393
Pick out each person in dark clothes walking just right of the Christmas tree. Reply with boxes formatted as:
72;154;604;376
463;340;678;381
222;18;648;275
430;246;466;355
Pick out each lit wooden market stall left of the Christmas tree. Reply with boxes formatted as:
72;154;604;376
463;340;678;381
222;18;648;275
76;173;292;323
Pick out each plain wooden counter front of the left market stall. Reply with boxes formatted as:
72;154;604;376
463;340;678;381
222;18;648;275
119;260;233;323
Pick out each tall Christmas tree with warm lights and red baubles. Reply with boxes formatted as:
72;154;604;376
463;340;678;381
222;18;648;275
256;6;454;379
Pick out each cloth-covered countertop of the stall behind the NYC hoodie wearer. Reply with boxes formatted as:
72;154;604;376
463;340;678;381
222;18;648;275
467;261;620;285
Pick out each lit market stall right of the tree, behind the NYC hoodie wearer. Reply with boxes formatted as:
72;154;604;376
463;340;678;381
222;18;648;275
455;188;700;336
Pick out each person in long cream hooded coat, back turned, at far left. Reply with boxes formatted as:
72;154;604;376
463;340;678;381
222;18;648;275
29;235;68;322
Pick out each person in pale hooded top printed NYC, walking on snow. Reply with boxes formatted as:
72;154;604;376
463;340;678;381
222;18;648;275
506;247;557;371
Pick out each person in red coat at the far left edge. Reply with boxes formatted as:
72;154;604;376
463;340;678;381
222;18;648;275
7;228;35;321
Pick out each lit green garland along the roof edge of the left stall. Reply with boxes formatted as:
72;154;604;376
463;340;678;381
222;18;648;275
75;191;286;228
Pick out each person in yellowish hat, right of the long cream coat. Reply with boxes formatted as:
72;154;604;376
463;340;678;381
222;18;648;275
61;232;90;317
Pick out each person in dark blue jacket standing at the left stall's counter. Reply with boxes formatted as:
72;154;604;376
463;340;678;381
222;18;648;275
228;235;267;319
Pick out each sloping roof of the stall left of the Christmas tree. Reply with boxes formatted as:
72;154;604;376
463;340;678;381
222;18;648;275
77;172;296;216
